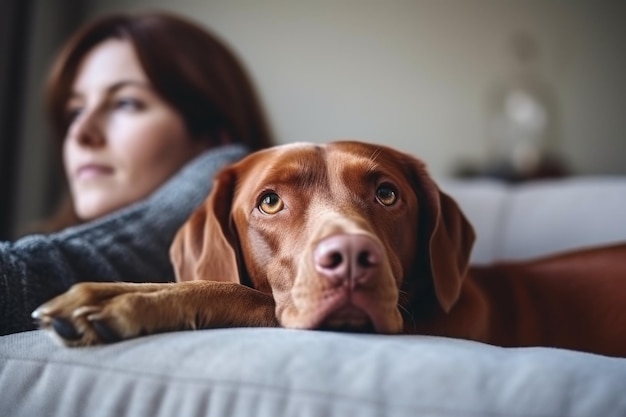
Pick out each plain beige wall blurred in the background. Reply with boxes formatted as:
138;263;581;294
83;0;626;174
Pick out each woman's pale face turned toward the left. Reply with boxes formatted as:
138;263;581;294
63;39;206;220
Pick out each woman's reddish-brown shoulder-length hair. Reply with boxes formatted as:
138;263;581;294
33;12;273;232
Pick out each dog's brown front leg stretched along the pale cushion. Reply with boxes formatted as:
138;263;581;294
33;281;278;346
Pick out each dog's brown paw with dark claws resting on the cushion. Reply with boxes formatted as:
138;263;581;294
32;283;151;346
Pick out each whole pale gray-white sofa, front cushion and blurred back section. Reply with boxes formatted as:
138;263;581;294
0;177;626;417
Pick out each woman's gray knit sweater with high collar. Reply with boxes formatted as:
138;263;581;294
0;146;246;334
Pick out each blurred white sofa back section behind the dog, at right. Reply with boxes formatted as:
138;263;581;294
440;177;626;264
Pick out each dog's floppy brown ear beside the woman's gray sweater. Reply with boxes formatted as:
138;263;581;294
170;168;239;282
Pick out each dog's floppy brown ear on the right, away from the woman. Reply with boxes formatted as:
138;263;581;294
404;159;475;312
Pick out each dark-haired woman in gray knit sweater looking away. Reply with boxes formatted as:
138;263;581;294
0;13;272;334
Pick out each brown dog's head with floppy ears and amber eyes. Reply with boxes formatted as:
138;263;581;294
171;142;474;333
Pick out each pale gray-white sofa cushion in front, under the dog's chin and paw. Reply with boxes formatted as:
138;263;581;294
0;329;626;417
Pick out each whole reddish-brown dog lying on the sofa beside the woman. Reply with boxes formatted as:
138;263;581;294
33;142;626;355
